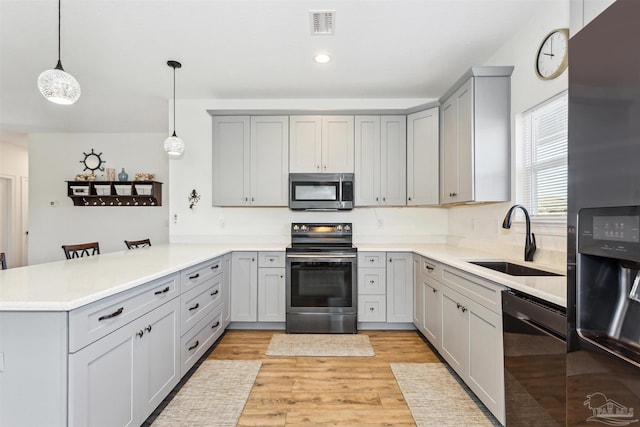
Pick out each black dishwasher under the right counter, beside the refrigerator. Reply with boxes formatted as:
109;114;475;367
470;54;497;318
502;290;567;427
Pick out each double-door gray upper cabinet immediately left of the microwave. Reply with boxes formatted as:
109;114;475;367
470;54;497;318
213;116;289;206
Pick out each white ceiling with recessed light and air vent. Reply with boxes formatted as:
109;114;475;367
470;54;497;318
0;0;556;140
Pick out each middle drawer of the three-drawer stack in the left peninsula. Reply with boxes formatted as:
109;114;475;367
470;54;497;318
180;274;222;335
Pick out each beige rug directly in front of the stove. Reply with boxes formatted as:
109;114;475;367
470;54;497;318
265;334;375;357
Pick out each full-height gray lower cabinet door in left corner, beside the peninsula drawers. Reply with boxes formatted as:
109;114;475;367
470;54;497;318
231;252;258;322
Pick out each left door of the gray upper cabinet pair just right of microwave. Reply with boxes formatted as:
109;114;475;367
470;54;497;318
355;116;381;206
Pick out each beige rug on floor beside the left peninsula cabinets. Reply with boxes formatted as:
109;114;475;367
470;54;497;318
153;360;262;427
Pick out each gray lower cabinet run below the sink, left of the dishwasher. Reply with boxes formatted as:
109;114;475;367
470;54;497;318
413;255;505;425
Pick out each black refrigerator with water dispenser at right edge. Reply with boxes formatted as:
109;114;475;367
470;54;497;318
566;0;640;426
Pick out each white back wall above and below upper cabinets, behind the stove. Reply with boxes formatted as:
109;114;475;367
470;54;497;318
170;99;447;244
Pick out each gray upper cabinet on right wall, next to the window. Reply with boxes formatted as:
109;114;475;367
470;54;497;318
440;67;513;204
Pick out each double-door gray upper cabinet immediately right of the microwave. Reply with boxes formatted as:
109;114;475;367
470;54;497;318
355;115;407;206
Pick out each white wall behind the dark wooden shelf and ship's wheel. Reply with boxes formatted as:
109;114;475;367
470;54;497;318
29;133;169;264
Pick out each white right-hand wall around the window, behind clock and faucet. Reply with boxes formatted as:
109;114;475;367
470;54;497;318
448;1;571;267
